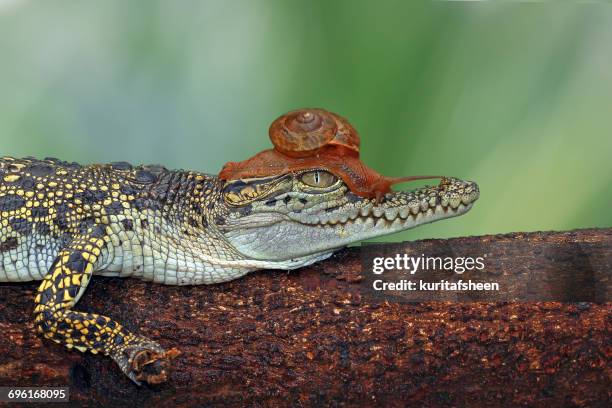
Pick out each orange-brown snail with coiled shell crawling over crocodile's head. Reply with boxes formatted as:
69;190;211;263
219;108;442;200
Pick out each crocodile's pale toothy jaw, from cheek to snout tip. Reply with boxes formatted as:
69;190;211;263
225;179;479;261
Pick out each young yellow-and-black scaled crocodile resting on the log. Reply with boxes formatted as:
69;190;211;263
0;157;479;384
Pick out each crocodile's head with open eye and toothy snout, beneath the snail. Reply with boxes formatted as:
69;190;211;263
217;170;479;267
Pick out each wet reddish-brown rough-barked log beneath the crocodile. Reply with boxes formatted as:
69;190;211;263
0;229;612;406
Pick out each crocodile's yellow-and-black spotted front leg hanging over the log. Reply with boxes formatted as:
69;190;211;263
34;226;178;385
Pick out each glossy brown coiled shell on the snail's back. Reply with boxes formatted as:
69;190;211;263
268;108;359;157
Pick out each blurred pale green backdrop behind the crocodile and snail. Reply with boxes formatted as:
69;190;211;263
0;0;612;240
